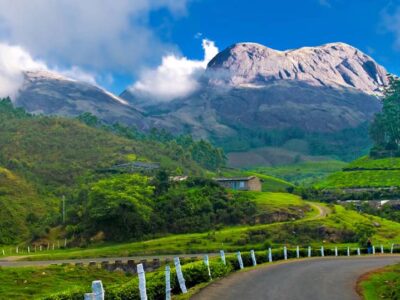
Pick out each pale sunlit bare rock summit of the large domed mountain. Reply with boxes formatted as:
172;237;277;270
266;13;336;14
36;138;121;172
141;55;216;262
207;43;387;95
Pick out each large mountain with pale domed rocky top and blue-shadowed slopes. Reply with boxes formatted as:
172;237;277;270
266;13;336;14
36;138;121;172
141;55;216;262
121;43;388;166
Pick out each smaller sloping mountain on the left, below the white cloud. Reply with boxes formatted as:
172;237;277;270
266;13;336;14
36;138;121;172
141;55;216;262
14;70;146;129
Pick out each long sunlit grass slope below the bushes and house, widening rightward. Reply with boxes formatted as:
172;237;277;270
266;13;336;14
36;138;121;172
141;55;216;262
3;193;400;260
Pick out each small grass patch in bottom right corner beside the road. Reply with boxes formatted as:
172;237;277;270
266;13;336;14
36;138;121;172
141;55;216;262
358;264;400;300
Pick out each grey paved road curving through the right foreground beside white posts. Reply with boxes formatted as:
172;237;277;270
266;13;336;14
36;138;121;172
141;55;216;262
192;256;400;300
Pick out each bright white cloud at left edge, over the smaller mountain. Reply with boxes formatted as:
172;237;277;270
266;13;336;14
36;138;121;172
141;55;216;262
0;43;96;99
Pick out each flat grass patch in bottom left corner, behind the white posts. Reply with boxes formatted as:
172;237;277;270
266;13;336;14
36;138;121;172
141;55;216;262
0;266;132;300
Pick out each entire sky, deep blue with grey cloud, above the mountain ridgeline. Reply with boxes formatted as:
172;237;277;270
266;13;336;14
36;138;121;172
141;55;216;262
0;0;400;95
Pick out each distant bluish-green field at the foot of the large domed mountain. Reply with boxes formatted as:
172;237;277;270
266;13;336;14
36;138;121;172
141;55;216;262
251;160;346;185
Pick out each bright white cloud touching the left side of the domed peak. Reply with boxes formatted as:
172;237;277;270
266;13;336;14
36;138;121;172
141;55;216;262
129;39;219;101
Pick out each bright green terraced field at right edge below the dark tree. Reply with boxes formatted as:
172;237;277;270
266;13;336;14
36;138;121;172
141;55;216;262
315;157;400;189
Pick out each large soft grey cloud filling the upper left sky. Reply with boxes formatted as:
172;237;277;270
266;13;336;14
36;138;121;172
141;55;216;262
0;0;190;73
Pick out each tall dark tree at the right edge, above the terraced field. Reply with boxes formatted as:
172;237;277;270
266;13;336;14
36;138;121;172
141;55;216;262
370;77;400;157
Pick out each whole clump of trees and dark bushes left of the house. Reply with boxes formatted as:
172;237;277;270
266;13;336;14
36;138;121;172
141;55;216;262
67;175;256;241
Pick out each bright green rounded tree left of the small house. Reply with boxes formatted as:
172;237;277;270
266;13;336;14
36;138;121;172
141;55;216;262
86;174;154;241
